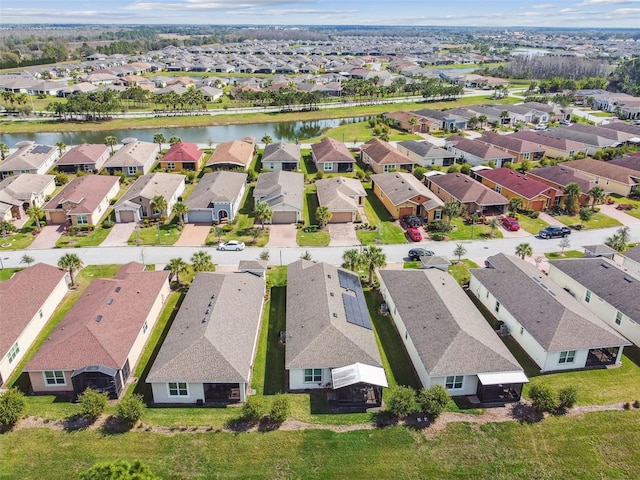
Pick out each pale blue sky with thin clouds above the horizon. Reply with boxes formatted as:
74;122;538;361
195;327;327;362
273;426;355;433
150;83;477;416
0;0;640;28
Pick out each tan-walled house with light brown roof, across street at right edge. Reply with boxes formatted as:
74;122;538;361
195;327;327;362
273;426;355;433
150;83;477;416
562;158;640;197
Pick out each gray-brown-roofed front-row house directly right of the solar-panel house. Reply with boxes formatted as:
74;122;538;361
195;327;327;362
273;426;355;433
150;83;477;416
378;269;529;404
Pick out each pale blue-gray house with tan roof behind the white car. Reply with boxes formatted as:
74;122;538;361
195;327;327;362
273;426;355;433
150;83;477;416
185;171;247;223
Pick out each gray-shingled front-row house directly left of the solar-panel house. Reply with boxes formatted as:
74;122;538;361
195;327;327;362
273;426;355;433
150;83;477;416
147;272;265;404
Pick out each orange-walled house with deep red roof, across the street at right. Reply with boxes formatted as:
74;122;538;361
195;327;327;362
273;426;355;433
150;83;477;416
475;167;560;212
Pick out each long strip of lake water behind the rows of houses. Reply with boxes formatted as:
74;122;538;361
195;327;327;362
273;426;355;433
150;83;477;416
0;117;370;147
